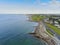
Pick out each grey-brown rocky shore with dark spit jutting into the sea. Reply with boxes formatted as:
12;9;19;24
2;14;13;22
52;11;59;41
28;16;56;45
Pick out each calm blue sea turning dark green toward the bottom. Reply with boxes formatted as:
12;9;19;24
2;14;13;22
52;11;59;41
0;14;46;45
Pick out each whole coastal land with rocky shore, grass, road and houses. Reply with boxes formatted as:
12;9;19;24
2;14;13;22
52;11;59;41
29;14;60;45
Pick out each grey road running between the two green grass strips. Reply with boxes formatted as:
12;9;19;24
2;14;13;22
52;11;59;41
43;22;60;45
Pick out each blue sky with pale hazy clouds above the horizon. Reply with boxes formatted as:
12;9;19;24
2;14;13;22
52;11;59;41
0;0;60;14
